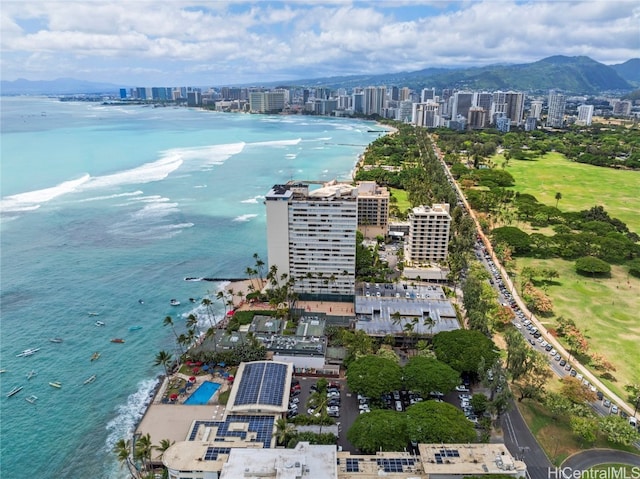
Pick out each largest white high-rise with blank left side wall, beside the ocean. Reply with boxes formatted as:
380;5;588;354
265;181;358;299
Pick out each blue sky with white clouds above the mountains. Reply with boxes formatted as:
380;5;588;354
0;0;640;87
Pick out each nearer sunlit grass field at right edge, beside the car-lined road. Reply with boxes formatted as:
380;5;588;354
516;258;640;398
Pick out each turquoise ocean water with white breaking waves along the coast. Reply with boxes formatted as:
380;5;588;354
0;97;379;479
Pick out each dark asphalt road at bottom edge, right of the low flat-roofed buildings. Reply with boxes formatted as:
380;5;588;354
501;401;552;479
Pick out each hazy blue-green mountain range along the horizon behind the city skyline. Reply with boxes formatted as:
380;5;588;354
0;55;640;95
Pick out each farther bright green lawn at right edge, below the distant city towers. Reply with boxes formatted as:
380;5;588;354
500;153;640;233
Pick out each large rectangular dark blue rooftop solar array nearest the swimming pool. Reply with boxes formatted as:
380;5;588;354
234;362;287;406
